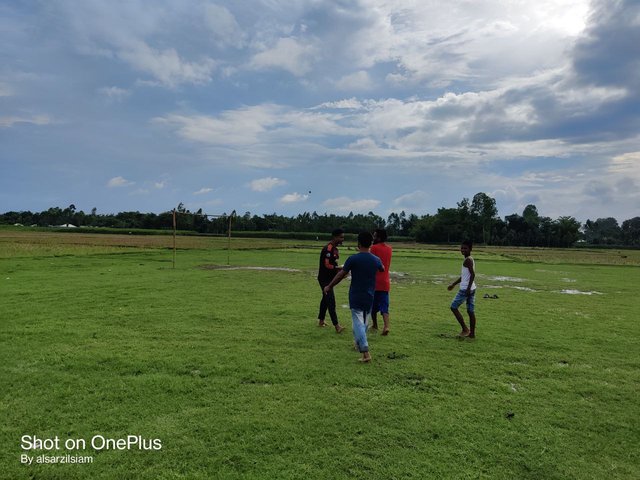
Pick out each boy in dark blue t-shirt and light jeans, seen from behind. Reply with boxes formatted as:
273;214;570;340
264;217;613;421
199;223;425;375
324;232;384;362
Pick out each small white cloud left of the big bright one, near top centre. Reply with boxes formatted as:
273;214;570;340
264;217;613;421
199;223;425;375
250;37;316;77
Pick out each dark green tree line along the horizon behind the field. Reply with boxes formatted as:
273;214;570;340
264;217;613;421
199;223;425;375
0;192;640;247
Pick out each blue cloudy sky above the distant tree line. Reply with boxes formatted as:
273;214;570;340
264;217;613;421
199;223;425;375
0;0;640;222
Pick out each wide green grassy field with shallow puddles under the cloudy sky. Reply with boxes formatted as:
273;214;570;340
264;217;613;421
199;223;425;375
0;230;640;480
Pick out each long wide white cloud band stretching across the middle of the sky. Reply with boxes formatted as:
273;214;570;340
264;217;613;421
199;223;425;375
155;58;636;171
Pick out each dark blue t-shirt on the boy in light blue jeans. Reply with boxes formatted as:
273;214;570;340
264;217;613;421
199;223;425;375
342;252;384;312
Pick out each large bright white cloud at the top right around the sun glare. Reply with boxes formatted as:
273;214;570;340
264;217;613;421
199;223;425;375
348;0;589;86
